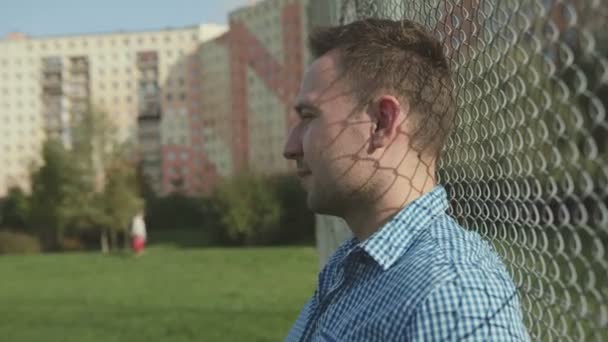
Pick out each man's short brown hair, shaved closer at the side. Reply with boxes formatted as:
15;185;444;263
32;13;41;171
308;19;455;157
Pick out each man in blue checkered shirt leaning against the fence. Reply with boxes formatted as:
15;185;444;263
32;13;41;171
284;19;529;342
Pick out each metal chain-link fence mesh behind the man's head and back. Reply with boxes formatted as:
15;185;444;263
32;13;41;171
332;0;608;341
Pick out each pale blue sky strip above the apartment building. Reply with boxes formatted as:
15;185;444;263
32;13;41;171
0;0;251;37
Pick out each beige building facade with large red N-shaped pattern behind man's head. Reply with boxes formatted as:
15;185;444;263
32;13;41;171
227;0;308;173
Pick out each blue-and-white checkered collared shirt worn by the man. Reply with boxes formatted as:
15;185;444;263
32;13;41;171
286;186;529;342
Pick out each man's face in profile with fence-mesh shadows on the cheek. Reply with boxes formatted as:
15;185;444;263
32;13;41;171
284;53;373;215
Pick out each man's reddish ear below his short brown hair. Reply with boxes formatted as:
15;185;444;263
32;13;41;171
370;95;403;151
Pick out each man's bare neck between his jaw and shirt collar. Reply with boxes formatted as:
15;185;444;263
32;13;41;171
343;182;435;241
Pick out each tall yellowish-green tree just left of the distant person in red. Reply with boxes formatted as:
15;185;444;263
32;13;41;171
68;109;142;252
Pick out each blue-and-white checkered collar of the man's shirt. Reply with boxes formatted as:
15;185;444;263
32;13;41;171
350;185;449;271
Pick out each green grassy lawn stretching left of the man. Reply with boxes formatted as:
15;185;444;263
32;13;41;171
0;245;318;342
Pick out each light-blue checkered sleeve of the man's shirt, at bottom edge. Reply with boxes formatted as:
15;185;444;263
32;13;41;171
405;268;530;341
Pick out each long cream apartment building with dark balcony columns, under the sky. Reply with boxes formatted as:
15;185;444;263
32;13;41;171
0;24;226;196
